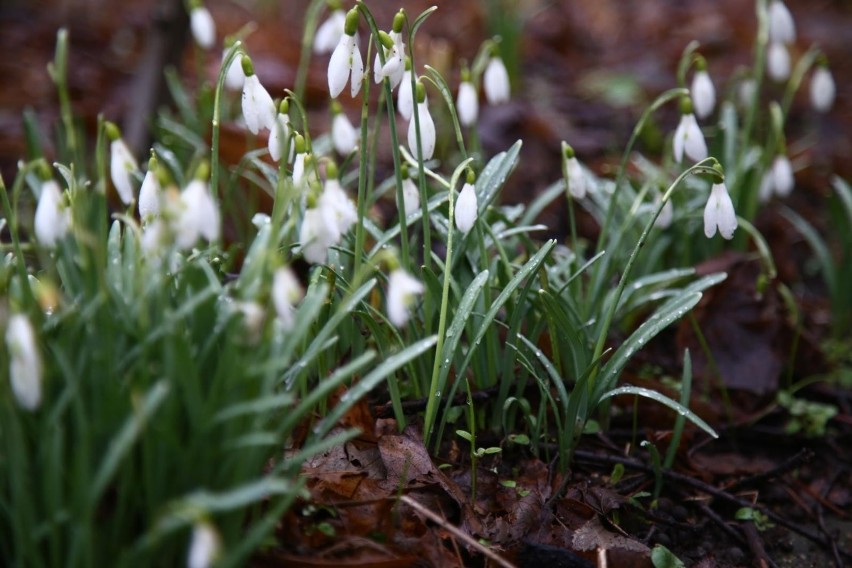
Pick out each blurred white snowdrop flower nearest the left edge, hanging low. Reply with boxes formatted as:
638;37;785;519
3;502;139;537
6;314;42;411
